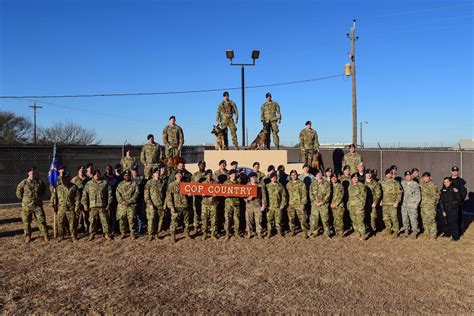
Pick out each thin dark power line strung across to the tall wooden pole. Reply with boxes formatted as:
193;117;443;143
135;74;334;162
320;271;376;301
0;74;344;99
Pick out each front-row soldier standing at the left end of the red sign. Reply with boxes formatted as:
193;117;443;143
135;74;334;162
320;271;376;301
166;171;191;243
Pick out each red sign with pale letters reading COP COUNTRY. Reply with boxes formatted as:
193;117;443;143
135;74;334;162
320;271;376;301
179;182;257;197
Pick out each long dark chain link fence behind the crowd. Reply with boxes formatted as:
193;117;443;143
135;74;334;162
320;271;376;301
0;145;474;210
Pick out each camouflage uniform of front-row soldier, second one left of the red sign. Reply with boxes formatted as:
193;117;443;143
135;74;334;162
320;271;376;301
145;178;166;235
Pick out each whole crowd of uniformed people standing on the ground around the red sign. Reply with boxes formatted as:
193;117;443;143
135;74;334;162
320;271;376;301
17;146;465;242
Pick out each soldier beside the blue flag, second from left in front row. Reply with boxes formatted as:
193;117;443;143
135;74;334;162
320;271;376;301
52;172;81;242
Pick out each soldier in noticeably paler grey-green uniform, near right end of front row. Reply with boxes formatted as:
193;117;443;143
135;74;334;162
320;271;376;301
402;171;421;239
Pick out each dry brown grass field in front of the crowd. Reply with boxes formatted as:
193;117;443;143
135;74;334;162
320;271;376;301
0;207;474;314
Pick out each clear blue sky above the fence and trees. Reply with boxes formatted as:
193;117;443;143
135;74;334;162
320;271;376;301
0;0;474;146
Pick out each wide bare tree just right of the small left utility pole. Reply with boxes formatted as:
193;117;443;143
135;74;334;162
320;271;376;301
38;122;101;145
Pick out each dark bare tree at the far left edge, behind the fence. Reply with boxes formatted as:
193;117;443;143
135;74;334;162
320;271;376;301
0;112;33;144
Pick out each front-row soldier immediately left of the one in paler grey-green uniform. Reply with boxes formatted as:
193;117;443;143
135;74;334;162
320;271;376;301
380;169;402;238
